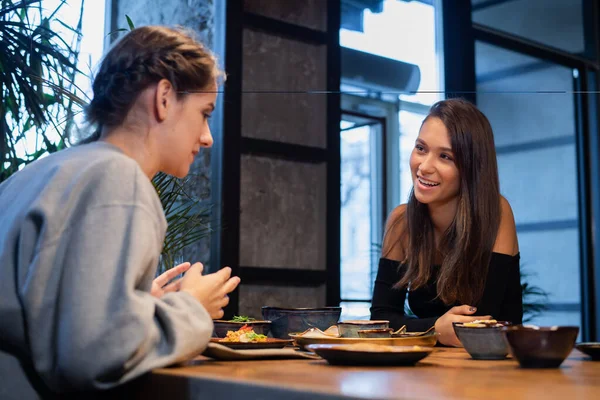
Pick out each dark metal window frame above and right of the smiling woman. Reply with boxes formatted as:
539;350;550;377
442;0;600;341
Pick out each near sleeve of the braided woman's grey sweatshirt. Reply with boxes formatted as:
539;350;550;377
21;204;213;392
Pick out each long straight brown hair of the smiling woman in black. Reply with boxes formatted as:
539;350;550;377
386;99;501;304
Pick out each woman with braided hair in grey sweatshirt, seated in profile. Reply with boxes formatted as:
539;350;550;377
0;27;239;399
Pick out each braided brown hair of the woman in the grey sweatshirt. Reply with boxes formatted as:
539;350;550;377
80;26;224;144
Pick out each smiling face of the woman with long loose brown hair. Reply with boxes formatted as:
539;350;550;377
410;117;460;205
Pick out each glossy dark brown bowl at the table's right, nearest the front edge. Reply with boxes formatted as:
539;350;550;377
503;325;579;368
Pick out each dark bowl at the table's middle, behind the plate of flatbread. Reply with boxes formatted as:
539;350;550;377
262;307;342;339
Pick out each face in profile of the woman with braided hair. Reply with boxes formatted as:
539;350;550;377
161;85;217;178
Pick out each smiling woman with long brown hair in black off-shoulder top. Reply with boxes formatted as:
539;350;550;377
371;99;523;346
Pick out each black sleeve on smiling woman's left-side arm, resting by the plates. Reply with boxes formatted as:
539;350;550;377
371;258;437;332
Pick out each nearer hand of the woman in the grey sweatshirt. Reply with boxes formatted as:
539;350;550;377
180;263;240;319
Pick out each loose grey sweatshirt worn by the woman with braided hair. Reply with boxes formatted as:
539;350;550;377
0;142;213;399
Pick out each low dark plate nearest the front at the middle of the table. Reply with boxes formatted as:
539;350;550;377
306;344;433;366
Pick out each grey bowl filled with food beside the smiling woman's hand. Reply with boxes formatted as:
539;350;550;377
452;321;510;360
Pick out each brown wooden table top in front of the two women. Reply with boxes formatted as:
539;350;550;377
134;348;600;400
